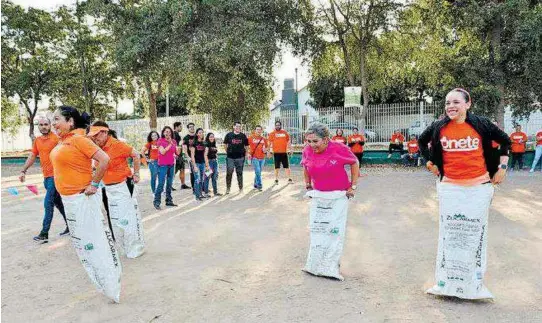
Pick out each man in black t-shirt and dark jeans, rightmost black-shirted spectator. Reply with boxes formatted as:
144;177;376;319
224;122;248;194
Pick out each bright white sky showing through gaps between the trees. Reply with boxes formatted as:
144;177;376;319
12;0;310;113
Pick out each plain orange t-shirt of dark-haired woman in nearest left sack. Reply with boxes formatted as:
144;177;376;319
50;131;100;195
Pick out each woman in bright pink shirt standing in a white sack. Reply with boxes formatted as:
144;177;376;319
301;123;359;280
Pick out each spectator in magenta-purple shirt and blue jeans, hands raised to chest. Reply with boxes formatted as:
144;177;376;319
153;126;178;210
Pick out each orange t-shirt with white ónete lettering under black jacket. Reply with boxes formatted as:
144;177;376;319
440;122;489;180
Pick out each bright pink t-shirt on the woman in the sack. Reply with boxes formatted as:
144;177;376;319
301;141;358;192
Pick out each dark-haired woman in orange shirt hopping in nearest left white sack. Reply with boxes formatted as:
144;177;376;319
50;106;121;303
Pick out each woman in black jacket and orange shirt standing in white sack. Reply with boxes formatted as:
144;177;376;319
419;89;510;299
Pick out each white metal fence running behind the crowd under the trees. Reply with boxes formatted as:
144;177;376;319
2;102;542;152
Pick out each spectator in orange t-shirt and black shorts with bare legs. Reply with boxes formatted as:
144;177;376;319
268;121;293;185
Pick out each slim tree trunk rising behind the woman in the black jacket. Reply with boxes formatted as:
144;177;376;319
490;13;505;129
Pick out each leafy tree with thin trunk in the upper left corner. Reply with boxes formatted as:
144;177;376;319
2;0;62;140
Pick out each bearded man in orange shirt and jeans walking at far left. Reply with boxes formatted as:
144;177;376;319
19;117;70;243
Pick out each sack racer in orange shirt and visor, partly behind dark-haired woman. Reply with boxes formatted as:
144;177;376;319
87;121;145;258
